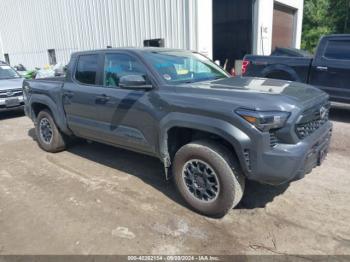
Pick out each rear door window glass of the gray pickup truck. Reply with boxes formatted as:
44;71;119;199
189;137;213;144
75;55;98;85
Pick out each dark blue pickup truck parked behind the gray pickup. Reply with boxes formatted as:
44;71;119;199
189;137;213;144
242;35;350;103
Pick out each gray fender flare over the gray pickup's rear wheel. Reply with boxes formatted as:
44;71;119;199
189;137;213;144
29;94;72;135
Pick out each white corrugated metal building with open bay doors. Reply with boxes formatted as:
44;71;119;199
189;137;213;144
0;0;303;68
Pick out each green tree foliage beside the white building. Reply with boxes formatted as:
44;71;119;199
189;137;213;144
302;0;350;52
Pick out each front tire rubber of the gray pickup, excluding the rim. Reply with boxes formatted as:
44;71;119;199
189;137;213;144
173;140;245;218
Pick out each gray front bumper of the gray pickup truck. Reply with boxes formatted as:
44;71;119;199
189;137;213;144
247;122;332;185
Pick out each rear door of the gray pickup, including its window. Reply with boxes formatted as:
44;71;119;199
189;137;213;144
63;53;104;139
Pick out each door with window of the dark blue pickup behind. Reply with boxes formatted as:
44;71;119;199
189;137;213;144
310;36;350;103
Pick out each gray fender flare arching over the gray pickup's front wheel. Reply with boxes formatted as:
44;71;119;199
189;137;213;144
159;113;251;176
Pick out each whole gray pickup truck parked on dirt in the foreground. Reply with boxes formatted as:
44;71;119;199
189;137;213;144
23;48;332;217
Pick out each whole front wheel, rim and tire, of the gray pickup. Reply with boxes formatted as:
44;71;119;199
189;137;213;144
173;141;245;217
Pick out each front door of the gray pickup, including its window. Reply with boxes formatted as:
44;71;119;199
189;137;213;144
96;52;157;154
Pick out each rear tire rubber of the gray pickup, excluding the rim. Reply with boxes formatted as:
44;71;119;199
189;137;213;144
35;109;68;153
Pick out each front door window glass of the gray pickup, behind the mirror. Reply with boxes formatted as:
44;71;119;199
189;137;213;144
103;54;146;87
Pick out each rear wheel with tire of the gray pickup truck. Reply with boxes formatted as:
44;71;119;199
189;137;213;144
35;110;67;153
